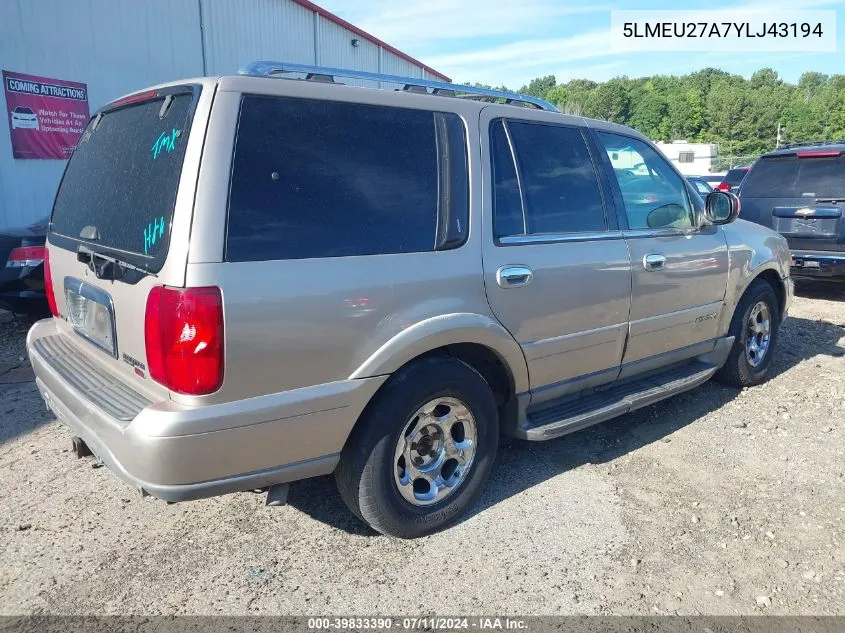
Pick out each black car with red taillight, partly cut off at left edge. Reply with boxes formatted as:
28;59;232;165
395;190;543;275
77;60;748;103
0;218;50;317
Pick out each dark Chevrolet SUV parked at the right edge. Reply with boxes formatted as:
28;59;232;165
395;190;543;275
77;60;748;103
739;141;845;281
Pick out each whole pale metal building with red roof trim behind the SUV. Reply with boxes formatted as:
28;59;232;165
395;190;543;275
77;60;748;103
0;0;449;227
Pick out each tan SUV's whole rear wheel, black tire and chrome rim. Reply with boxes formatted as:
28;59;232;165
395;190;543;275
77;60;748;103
335;356;499;538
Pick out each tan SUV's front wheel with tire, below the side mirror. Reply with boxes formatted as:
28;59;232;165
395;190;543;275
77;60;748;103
716;279;780;388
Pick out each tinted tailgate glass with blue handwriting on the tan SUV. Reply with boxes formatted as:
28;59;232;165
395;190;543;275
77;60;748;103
51;89;194;272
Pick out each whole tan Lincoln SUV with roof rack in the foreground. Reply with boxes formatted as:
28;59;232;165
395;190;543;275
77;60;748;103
28;62;792;537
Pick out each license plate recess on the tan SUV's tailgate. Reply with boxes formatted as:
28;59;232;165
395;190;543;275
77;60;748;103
65;277;117;358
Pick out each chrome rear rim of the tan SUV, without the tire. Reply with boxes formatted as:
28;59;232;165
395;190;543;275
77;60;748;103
393;398;477;506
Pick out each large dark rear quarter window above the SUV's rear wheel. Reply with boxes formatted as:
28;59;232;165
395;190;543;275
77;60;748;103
226;95;469;262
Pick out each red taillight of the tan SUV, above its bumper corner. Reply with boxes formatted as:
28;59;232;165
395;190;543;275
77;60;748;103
144;286;223;396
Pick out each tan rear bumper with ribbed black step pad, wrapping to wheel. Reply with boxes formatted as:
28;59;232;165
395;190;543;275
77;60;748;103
27;319;385;501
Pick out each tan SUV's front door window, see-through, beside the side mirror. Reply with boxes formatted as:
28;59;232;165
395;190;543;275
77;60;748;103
598;132;693;229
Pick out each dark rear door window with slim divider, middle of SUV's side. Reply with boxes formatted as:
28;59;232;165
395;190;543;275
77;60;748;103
490;120;607;238
